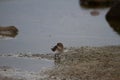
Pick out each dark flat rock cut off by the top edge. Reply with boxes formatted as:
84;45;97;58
79;0;114;8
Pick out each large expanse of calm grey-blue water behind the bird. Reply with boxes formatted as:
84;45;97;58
0;0;120;54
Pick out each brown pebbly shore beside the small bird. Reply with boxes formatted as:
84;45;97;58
0;46;120;80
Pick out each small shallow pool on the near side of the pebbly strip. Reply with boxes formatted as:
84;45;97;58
0;57;54;72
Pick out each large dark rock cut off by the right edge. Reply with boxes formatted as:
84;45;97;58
105;0;120;35
